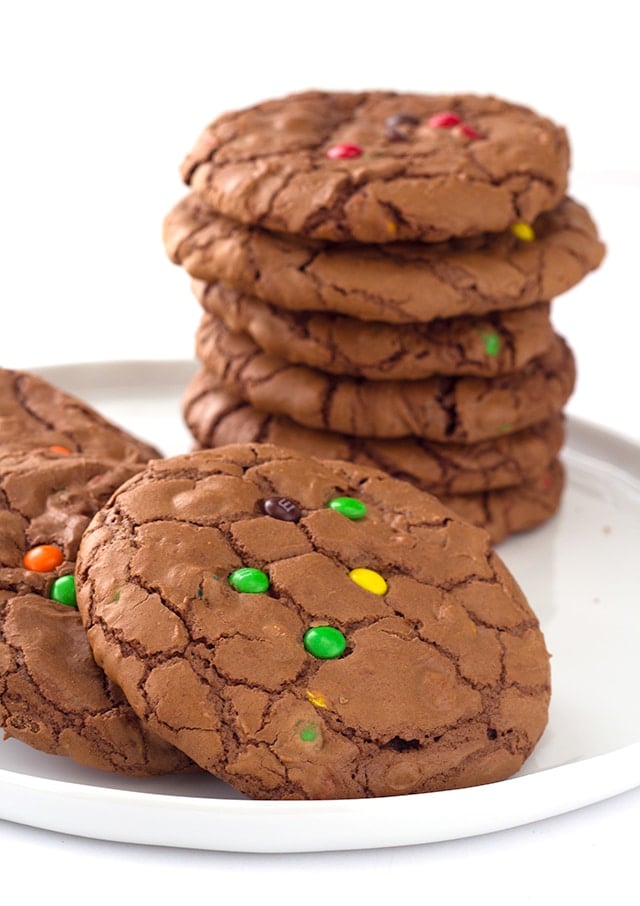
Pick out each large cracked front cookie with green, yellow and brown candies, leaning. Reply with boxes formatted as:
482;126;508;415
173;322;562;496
77;445;550;799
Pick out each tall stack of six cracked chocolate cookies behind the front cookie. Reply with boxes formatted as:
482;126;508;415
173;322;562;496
164;92;604;541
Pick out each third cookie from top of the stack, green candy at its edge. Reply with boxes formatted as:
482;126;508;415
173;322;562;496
194;283;555;380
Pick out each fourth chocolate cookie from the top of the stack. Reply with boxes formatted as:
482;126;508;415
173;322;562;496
196;314;575;443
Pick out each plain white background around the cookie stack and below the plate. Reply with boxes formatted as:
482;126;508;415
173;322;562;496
0;0;640;903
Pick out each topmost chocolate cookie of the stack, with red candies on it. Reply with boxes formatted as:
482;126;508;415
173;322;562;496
182;91;569;243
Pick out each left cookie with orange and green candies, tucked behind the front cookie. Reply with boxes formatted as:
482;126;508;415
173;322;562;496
0;450;194;776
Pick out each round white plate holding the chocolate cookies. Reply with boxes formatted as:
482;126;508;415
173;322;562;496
0;362;640;852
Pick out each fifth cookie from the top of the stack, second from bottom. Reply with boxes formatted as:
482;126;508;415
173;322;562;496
182;369;565;497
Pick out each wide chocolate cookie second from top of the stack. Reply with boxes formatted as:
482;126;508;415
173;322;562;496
163;193;604;323
